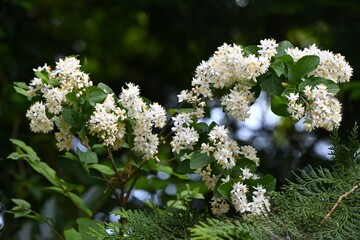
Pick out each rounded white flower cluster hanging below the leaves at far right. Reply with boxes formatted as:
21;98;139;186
287;84;342;132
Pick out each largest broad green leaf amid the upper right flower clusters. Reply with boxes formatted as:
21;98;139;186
288;55;320;84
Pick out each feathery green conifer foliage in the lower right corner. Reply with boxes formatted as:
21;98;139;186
191;126;360;239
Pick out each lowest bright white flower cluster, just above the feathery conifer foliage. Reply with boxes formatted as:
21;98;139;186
230;182;270;215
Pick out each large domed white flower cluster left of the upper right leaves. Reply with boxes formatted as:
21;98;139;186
178;39;278;120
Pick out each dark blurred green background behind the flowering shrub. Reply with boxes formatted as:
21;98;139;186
0;0;360;239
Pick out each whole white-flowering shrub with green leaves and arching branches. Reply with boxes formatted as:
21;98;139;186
9;39;352;237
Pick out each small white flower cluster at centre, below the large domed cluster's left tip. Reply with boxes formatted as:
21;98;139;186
170;113;199;154
